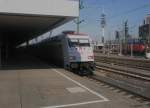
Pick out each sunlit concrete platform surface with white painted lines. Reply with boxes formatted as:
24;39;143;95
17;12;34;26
0;67;148;108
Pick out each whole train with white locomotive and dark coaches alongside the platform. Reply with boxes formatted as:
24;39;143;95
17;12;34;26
21;31;94;75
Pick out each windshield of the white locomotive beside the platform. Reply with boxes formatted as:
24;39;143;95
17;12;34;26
68;39;90;47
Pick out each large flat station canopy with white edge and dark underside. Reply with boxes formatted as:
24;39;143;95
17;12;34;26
0;0;79;45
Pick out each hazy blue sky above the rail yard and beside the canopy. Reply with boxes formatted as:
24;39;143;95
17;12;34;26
48;0;150;39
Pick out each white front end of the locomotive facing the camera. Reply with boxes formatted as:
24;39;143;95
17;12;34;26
68;36;94;74
